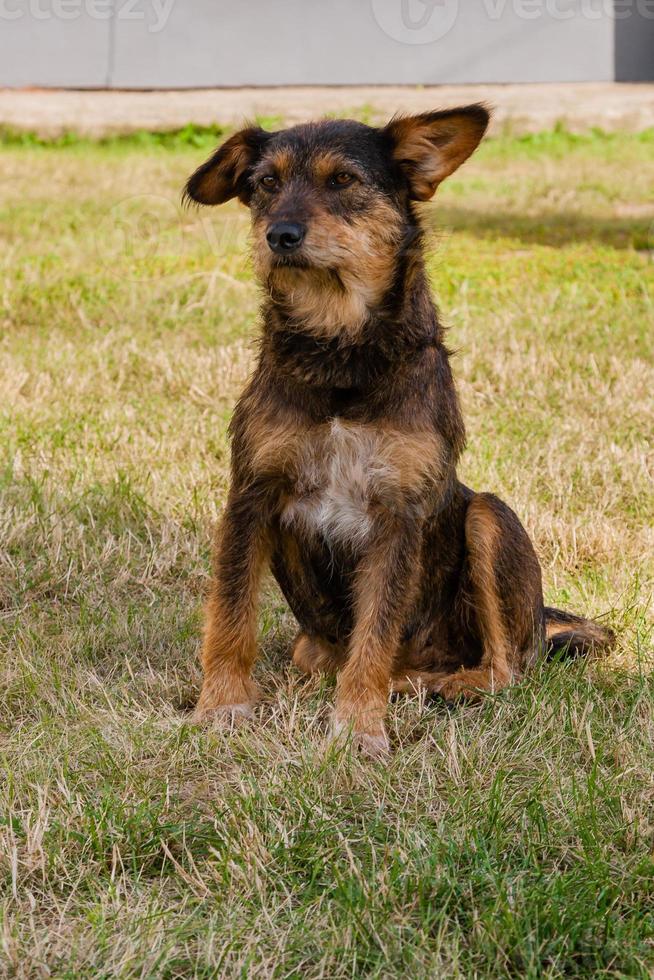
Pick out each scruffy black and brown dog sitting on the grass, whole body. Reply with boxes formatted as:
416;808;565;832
186;105;611;754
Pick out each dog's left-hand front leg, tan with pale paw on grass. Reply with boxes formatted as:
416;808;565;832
195;490;269;721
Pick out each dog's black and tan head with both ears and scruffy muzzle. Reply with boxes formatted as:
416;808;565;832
186;105;489;334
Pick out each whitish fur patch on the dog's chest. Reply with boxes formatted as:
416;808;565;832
282;419;396;548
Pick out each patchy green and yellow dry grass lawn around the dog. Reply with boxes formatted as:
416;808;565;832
0;126;654;980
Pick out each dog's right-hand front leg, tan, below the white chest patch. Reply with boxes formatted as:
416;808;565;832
334;516;420;755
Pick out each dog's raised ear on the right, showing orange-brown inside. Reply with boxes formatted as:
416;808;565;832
383;105;490;201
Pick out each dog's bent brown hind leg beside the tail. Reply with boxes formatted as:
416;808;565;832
436;494;543;700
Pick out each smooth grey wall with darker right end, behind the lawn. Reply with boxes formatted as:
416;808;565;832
0;0;654;88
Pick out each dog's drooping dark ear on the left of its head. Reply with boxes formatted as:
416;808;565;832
184;126;271;204
